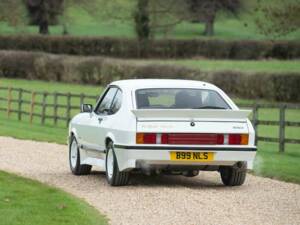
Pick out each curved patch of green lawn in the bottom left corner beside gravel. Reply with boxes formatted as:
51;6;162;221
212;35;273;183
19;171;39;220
0;171;107;225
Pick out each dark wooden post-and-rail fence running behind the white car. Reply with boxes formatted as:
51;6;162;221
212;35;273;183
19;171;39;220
0;87;300;152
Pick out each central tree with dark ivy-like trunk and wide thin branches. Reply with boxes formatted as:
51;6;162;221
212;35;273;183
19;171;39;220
98;0;186;41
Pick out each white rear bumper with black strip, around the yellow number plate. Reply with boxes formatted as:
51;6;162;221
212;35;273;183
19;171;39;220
114;145;256;171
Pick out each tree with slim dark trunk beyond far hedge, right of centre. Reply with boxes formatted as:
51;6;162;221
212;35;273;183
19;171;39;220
187;0;243;36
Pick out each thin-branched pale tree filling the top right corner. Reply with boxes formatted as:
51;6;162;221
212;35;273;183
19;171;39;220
256;0;300;36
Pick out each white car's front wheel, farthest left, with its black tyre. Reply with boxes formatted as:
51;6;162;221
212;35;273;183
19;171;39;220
69;136;92;176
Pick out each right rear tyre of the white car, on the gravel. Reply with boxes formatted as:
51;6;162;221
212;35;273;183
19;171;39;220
220;162;247;186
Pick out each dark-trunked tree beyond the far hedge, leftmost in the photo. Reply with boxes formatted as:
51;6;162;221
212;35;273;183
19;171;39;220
25;0;64;34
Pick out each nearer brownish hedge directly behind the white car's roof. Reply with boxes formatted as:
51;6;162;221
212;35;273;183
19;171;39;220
0;51;300;102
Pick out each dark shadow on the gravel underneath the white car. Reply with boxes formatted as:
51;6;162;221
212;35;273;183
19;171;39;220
91;171;234;189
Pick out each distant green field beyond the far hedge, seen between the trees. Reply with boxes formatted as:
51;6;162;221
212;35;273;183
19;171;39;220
0;7;300;40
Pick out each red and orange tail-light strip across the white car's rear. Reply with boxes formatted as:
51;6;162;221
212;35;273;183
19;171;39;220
136;133;249;145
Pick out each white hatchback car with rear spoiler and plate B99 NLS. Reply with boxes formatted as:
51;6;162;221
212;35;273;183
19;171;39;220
69;79;256;186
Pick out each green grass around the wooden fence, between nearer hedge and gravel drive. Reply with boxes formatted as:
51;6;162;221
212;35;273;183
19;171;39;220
0;79;300;183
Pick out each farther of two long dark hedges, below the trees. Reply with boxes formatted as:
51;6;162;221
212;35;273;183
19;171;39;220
0;36;300;59
